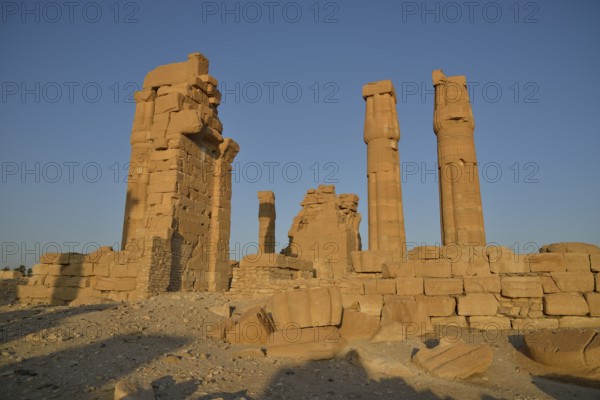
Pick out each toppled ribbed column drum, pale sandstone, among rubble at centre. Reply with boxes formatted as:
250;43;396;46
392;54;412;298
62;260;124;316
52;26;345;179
267;288;342;330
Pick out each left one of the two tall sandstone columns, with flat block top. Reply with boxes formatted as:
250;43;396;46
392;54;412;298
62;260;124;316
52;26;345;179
363;80;406;255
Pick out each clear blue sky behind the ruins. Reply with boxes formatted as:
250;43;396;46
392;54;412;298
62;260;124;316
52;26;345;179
0;0;600;267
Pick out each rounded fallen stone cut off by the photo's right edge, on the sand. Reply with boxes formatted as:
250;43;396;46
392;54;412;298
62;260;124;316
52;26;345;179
524;330;600;368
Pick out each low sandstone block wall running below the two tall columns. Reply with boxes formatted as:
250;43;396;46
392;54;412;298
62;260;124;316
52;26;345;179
341;246;600;330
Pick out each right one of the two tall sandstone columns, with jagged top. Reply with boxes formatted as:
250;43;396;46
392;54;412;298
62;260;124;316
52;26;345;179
432;70;486;245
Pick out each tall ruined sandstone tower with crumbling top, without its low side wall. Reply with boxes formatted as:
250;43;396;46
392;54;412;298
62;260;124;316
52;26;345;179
123;53;239;294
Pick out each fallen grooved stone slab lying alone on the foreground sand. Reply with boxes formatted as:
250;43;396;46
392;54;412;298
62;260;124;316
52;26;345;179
413;342;494;379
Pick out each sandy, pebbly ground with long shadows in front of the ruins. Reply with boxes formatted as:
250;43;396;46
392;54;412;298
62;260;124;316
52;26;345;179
0;293;600;400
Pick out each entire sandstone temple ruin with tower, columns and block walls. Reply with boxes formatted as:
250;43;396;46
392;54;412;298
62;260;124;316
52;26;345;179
12;53;600;342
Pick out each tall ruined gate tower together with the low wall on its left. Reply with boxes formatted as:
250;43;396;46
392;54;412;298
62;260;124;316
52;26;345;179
19;53;239;304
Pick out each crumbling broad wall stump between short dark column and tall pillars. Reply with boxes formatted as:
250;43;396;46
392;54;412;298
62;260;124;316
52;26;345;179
282;185;361;277
